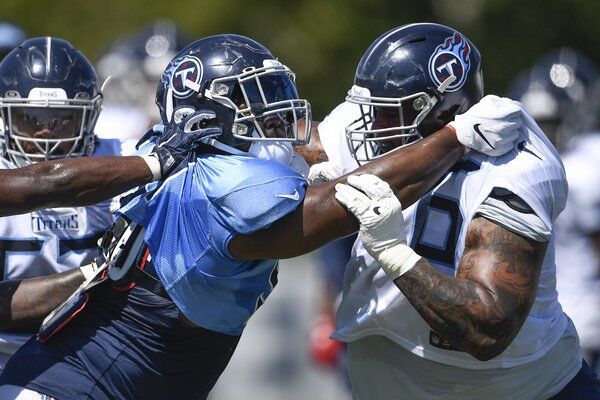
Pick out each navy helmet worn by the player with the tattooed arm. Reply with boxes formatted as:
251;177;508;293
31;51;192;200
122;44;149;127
346;23;483;164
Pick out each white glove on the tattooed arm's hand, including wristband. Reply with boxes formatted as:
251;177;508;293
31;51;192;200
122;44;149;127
335;174;421;280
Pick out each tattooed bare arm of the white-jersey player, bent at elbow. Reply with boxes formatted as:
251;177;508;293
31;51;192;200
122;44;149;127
394;216;547;361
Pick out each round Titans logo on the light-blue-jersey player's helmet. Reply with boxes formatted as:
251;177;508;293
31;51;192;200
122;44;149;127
163;56;203;99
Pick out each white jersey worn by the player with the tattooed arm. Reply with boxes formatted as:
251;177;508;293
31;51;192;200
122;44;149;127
319;101;581;396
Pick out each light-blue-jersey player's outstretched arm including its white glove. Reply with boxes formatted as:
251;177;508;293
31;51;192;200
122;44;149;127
229;96;522;260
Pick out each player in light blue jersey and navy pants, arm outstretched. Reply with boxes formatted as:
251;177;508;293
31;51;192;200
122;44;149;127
0;35;520;400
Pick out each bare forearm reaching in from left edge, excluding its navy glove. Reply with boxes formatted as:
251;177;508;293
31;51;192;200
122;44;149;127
0;157;153;216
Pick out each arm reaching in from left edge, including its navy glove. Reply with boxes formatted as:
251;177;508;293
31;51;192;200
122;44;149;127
0;110;222;216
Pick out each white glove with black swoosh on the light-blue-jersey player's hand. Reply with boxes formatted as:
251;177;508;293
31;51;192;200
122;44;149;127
448;95;523;157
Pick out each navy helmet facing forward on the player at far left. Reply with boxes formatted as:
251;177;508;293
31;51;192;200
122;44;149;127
0;37;102;166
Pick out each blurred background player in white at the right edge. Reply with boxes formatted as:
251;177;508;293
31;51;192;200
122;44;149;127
508;48;600;373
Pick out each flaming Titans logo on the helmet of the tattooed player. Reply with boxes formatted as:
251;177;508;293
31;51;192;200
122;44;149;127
429;32;471;92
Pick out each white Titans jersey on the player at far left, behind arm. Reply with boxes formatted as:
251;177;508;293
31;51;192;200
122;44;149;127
0;139;135;364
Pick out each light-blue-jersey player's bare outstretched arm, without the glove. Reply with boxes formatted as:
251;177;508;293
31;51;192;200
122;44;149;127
229;128;464;260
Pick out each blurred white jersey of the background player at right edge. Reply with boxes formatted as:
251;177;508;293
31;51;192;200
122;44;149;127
556;132;600;350
